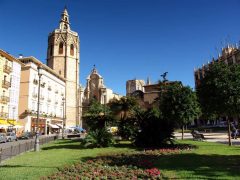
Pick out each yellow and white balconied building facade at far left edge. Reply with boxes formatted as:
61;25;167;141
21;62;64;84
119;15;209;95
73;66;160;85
0;50;22;129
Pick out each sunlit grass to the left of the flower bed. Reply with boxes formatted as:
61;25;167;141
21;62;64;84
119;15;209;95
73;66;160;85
0;140;137;180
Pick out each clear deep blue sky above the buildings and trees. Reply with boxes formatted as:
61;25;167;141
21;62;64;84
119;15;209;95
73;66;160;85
0;0;240;95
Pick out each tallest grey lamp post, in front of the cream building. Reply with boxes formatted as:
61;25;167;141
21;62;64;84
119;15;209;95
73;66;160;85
34;66;42;151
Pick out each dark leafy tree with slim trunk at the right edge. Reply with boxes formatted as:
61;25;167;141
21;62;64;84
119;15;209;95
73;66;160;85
197;62;240;146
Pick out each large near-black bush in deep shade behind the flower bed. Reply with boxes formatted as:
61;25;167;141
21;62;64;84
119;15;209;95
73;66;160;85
135;109;174;148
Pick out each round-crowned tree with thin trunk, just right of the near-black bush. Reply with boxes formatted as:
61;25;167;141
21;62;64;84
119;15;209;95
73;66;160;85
159;83;201;139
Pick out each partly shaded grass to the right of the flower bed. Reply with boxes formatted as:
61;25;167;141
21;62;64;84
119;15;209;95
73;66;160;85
154;141;240;179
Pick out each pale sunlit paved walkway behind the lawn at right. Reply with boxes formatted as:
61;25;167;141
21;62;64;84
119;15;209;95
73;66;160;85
174;133;240;146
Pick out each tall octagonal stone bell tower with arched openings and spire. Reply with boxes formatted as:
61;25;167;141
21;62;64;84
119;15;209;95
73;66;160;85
47;8;80;127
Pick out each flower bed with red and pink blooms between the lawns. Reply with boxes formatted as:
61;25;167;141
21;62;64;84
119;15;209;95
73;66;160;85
42;149;193;180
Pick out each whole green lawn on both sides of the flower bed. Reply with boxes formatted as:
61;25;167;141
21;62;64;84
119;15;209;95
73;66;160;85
0;140;240;180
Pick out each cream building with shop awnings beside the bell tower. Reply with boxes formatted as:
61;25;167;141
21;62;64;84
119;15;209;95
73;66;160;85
19;57;66;134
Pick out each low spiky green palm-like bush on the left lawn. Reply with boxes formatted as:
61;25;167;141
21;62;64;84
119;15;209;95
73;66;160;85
82;128;114;148
